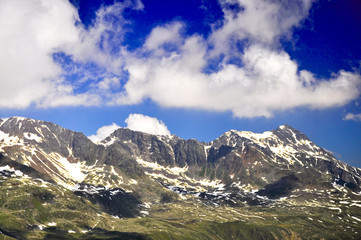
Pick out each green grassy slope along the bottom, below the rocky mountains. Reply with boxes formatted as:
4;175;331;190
0;174;361;240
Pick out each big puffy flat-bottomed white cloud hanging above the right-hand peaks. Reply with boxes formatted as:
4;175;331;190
115;41;361;117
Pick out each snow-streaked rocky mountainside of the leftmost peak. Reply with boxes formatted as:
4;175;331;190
0;117;104;185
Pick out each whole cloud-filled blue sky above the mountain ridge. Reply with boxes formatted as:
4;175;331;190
0;0;361;167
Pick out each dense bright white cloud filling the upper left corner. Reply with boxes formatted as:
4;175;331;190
0;0;82;108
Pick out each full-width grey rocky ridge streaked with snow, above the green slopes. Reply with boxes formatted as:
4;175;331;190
0;117;361;196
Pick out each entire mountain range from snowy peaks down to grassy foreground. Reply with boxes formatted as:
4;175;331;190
0;117;361;239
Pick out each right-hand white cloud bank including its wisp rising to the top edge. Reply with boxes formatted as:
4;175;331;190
112;0;361;117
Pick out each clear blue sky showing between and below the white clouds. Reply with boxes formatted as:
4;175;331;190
0;0;361;167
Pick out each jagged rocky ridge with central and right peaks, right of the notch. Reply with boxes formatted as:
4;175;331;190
100;125;361;195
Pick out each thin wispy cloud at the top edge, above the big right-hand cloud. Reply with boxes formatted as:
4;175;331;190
210;0;314;55
